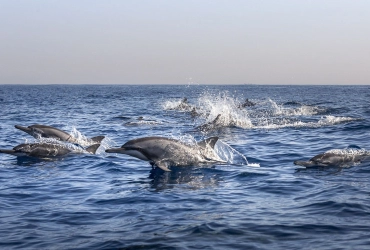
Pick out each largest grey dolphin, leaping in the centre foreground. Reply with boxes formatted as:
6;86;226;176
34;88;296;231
105;136;225;171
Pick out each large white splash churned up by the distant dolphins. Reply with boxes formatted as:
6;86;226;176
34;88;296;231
163;91;359;133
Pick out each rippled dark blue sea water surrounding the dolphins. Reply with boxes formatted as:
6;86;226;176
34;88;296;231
0;85;370;249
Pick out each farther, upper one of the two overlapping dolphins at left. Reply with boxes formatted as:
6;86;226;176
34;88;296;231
15;124;105;145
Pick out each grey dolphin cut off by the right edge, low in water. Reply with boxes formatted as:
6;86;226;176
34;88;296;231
294;151;369;167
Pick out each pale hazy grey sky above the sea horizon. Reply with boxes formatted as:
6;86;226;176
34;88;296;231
0;0;370;84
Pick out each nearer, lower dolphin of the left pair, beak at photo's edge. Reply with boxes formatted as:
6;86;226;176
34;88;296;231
0;143;100;158
